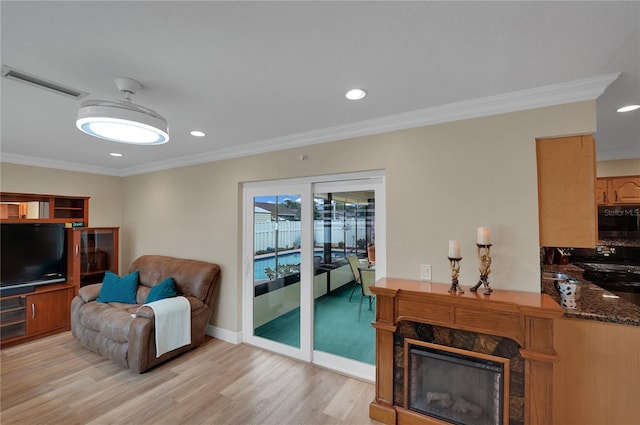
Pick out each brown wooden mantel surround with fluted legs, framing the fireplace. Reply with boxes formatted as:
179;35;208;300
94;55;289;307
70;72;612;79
369;278;563;425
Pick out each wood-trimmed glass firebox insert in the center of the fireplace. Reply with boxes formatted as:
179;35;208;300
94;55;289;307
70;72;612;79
405;340;509;425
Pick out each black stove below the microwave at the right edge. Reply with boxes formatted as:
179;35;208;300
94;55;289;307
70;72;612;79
571;247;640;306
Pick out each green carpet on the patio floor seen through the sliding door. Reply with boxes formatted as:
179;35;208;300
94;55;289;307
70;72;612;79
255;284;376;364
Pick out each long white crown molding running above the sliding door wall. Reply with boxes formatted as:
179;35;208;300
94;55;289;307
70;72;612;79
2;72;620;177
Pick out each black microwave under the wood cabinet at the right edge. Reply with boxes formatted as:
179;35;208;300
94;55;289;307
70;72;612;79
598;205;640;240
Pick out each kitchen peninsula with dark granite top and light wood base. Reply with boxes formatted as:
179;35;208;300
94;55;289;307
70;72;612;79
542;258;640;425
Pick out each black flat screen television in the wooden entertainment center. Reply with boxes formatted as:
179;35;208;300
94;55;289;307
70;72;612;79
0;223;67;296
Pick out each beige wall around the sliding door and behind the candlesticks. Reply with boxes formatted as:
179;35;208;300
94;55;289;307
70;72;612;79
3;101;596;332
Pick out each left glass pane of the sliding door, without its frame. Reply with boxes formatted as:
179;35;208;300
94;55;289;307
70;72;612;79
252;194;302;348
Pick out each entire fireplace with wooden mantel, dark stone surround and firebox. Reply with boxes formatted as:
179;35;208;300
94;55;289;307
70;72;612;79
369;278;563;425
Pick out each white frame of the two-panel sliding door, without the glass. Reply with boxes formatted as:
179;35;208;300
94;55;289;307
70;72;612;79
241;170;386;382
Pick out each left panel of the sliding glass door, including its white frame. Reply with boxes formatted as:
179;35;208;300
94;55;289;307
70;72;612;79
243;186;308;358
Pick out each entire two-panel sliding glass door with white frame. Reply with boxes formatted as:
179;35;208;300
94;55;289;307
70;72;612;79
243;171;385;379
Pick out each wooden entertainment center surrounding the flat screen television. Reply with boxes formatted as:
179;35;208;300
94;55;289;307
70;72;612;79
0;192;119;347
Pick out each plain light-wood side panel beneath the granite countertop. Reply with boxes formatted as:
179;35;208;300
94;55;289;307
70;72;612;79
552;317;640;425
